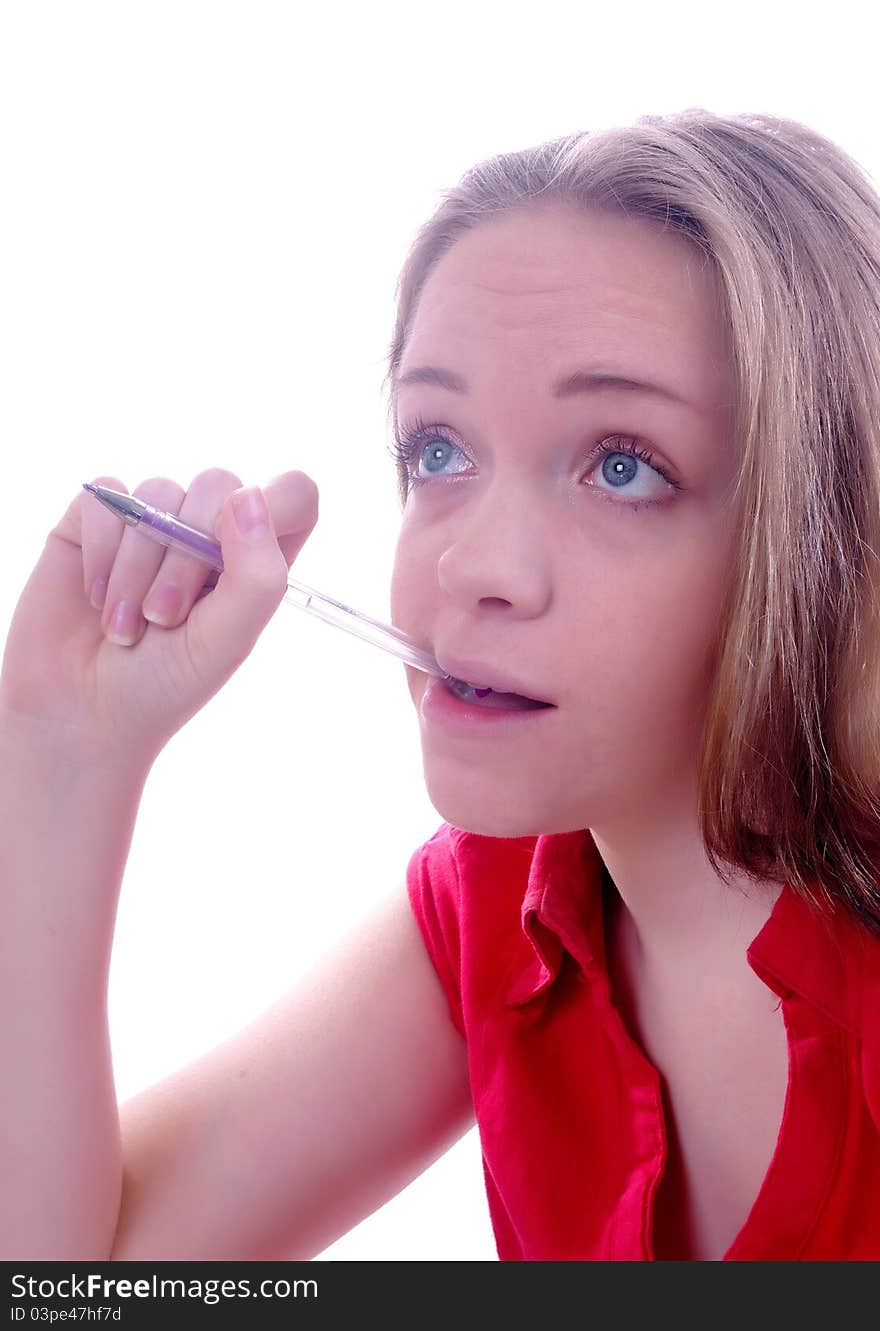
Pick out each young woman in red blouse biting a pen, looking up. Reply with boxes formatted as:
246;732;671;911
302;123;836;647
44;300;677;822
0;110;880;1260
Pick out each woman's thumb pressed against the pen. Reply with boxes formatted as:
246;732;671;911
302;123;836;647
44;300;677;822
190;486;288;675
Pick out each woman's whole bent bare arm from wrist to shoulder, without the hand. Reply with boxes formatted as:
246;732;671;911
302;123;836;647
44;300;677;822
0;718;474;1260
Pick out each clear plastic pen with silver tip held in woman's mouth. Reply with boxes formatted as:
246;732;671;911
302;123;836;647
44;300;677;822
83;482;449;679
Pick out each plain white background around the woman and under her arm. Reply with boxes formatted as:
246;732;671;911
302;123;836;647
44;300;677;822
0;0;880;1260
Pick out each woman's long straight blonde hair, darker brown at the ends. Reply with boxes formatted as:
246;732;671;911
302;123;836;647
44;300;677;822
383;108;880;936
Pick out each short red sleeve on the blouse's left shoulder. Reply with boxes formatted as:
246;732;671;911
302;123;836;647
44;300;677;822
406;823;467;1038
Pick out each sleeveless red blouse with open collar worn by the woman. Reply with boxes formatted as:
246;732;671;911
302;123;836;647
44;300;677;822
407;823;880;1262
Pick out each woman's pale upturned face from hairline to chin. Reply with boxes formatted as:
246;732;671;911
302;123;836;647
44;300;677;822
391;205;739;837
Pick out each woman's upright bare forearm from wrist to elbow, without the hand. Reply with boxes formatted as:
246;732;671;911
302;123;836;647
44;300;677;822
0;732;146;1260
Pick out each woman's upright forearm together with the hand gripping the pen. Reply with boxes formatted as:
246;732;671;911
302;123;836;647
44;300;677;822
0;467;330;1260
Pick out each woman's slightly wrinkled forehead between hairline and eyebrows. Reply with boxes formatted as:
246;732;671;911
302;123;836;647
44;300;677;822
398;205;731;402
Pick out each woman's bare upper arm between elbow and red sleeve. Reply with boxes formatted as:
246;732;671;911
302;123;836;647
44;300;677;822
110;885;475;1262
